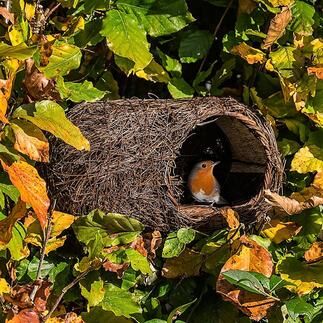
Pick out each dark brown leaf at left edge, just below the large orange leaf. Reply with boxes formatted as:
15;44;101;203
0;199;27;245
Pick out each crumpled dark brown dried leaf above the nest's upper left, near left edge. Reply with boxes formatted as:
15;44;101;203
24;58;60;100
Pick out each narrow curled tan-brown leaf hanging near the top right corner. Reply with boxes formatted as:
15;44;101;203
262;7;292;49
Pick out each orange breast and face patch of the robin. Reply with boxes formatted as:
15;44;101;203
188;169;216;195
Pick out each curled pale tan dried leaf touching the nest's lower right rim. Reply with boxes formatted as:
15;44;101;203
265;190;323;215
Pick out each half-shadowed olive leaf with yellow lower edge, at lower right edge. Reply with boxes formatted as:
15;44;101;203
276;255;323;295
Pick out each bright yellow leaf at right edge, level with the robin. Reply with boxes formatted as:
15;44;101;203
291;145;323;174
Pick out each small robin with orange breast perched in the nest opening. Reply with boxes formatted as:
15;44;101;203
188;160;227;204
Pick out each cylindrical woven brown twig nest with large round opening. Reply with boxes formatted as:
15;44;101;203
45;98;283;231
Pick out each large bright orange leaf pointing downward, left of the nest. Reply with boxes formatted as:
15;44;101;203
5;161;50;229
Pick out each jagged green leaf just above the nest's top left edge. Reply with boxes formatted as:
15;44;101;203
56;77;106;102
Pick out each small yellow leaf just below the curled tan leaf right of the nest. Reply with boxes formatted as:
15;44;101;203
261;219;302;244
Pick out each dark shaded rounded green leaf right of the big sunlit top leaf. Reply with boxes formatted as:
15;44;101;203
179;30;213;63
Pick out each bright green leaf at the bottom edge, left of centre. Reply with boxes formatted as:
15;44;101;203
102;283;142;318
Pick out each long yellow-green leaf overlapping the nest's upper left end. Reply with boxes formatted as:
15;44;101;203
13;100;90;150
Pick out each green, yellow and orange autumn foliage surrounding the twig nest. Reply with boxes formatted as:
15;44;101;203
0;0;323;323
